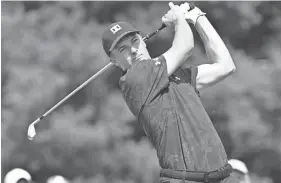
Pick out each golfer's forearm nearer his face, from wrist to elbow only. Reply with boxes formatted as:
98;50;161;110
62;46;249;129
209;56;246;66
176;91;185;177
172;19;194;59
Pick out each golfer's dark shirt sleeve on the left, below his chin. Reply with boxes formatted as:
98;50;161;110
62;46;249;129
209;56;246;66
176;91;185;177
118;55;169;105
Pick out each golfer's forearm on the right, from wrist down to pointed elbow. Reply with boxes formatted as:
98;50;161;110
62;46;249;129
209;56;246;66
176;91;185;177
195;16;235;70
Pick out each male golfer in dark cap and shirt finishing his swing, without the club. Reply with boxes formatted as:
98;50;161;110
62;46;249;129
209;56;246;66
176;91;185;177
102;3;237;183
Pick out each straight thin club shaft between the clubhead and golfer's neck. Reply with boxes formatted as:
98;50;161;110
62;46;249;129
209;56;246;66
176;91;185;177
32;62;113;125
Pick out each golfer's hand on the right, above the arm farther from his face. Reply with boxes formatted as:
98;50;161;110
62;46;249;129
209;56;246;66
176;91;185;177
180;3;206;25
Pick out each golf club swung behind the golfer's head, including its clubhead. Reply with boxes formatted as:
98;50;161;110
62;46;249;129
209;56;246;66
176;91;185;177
27;2;194;140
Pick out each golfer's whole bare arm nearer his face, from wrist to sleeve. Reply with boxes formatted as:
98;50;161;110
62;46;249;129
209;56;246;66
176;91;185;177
163;19;194;76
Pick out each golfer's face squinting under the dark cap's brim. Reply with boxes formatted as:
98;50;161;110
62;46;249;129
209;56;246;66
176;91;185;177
113;33;147;65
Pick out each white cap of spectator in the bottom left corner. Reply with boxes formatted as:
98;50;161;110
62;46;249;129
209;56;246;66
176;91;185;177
4;168;31;183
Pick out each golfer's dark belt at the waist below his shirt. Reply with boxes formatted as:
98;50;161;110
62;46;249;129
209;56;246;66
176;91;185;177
160;164;232;183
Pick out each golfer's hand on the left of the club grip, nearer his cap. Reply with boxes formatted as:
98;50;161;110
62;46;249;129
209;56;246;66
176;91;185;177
162;2;185;27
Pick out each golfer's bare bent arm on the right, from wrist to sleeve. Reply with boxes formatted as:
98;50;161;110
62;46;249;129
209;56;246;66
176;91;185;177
195;16;236;89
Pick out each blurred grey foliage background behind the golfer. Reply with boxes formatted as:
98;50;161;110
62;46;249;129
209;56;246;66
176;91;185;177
1;1;281;183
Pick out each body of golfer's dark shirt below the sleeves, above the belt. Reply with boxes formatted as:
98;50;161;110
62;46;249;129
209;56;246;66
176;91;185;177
140;72;227;171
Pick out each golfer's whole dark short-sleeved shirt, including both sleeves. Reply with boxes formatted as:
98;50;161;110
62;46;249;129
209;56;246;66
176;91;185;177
120;56;227;171
